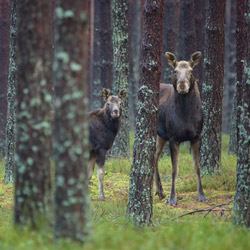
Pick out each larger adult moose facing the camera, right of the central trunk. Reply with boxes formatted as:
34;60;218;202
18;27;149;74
155;52;206;205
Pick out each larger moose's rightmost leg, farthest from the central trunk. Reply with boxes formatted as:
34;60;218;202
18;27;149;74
191;140;207;202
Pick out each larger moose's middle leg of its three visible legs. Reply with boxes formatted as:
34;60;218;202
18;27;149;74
166;142;179;206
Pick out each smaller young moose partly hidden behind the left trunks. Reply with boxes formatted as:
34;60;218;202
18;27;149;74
88;89;126;201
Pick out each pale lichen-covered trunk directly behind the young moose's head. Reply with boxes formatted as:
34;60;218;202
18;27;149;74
110;0;130;157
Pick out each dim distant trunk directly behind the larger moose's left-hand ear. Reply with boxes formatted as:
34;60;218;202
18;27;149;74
161;0;180;83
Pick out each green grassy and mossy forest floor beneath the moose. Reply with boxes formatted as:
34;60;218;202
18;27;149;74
0;136;250;250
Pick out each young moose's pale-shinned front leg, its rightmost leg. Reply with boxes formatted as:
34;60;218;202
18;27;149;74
96;150;106;201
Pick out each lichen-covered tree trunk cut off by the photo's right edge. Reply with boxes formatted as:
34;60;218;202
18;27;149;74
234;0;250;228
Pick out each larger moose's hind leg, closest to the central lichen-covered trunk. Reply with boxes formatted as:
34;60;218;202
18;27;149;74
154;136;166;200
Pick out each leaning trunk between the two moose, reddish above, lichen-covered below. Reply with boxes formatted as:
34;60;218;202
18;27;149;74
127;0;164;226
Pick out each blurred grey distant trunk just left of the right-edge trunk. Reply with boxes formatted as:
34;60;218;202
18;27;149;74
222;0;236;134
